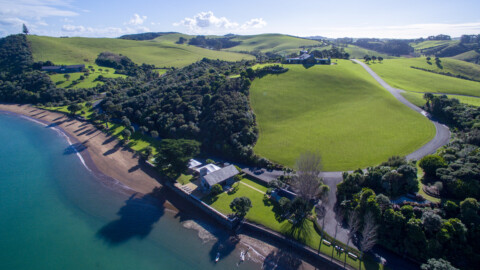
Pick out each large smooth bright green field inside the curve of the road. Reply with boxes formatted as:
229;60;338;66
250;60;435;171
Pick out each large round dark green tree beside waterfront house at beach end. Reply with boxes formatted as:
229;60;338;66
155;139;200;178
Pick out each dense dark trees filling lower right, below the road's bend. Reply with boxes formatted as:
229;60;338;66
337;94;480;269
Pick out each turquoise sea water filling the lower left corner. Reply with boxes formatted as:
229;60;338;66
0;113;260;269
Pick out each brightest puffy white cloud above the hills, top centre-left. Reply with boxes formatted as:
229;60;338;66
173;11;267;33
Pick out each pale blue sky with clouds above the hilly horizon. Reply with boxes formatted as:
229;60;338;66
0;0;480;38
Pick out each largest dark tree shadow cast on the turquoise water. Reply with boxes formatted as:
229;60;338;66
97;188;165;245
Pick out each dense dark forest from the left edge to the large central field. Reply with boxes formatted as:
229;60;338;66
0;35;262;162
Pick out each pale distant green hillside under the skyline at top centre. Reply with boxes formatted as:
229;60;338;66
225;34;322;53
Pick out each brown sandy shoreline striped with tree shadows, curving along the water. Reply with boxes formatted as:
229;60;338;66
0;103;322;269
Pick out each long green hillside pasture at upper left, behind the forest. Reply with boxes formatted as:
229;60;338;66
28;36;254;67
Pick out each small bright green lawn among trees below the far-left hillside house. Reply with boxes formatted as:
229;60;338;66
49;65;125;88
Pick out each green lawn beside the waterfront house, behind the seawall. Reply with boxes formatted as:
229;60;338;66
202;179;379;269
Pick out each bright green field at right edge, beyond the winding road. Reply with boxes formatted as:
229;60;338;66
370;57;480;97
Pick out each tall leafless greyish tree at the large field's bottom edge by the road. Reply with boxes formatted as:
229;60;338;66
293;152;322;201
